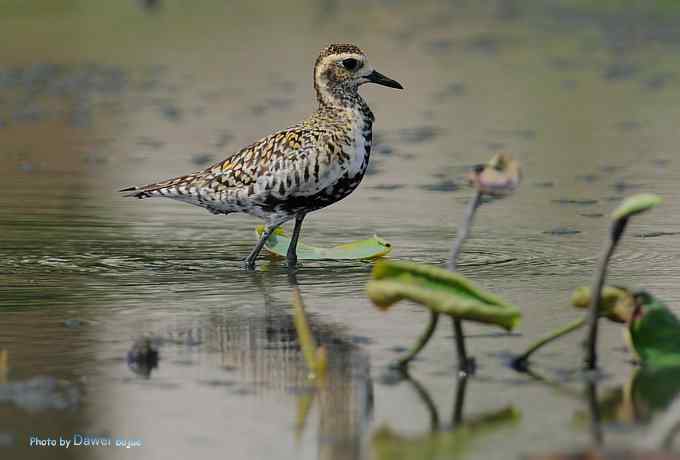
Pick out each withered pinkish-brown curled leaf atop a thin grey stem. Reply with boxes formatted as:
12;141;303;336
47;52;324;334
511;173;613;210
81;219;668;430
466;153;521;197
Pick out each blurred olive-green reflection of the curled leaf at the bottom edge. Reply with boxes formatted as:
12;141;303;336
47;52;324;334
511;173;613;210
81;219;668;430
371;407;520;460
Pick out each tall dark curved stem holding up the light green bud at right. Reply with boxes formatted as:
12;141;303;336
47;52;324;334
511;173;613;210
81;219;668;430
585;217;628;370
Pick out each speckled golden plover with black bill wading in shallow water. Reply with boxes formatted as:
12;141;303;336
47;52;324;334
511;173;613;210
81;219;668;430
121;44;403;269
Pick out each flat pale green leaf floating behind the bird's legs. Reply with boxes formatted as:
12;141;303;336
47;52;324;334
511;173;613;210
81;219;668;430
256;225;392;260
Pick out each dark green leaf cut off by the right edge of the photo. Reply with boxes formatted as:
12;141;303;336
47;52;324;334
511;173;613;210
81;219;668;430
628;292;680;367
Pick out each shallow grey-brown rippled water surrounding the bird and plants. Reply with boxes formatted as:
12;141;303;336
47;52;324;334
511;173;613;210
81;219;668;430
0;0;680;459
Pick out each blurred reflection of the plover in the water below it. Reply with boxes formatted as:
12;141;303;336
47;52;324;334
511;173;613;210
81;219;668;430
191;267;373;460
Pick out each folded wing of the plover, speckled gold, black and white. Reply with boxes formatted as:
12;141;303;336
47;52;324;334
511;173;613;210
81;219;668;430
122;124;349;212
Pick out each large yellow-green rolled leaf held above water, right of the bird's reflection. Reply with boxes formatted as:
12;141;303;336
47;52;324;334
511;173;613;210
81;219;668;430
367;260;521;330
